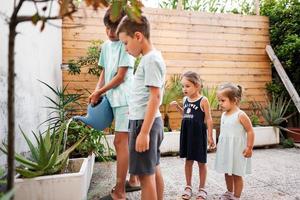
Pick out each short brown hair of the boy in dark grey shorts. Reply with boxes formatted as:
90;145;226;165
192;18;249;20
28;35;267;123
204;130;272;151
117;15;150;40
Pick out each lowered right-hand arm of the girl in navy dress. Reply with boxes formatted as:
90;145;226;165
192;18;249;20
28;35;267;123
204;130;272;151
201;97;216;149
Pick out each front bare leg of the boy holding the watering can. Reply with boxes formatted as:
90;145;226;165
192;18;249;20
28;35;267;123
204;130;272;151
112;132;129;199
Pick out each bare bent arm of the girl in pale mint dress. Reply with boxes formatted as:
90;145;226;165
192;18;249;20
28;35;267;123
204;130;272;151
239;113;254;158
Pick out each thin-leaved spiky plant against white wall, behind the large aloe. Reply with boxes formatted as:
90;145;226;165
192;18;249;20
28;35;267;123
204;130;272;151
40;81;81;129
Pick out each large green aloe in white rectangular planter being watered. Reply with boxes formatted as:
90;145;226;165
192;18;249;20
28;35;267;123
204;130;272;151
0;123;88;200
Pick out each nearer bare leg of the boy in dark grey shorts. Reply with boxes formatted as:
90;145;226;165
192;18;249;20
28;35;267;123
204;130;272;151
139;174;157;200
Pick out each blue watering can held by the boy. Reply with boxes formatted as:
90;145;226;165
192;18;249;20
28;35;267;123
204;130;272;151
73;96;113;131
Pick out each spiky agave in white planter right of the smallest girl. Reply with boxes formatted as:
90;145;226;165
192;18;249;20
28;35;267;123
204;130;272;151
253;94;291;146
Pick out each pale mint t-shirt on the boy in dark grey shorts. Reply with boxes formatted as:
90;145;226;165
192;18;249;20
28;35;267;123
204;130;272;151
129;50;166;120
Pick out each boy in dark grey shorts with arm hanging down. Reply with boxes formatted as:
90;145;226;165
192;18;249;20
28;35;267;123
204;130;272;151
117;16;166;200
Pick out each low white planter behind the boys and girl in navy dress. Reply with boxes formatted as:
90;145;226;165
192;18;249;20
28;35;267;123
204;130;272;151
106;129;216;153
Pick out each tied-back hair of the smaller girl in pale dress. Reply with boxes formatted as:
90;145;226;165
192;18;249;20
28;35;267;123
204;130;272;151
218;83;242;103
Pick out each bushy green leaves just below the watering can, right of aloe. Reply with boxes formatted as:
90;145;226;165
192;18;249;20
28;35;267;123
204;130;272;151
67;121;113;161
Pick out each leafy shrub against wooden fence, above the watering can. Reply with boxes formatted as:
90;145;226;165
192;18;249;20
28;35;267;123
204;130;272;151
68;40;103;76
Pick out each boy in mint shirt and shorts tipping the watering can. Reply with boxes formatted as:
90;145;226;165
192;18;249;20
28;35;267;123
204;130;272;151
89;8;140;199
